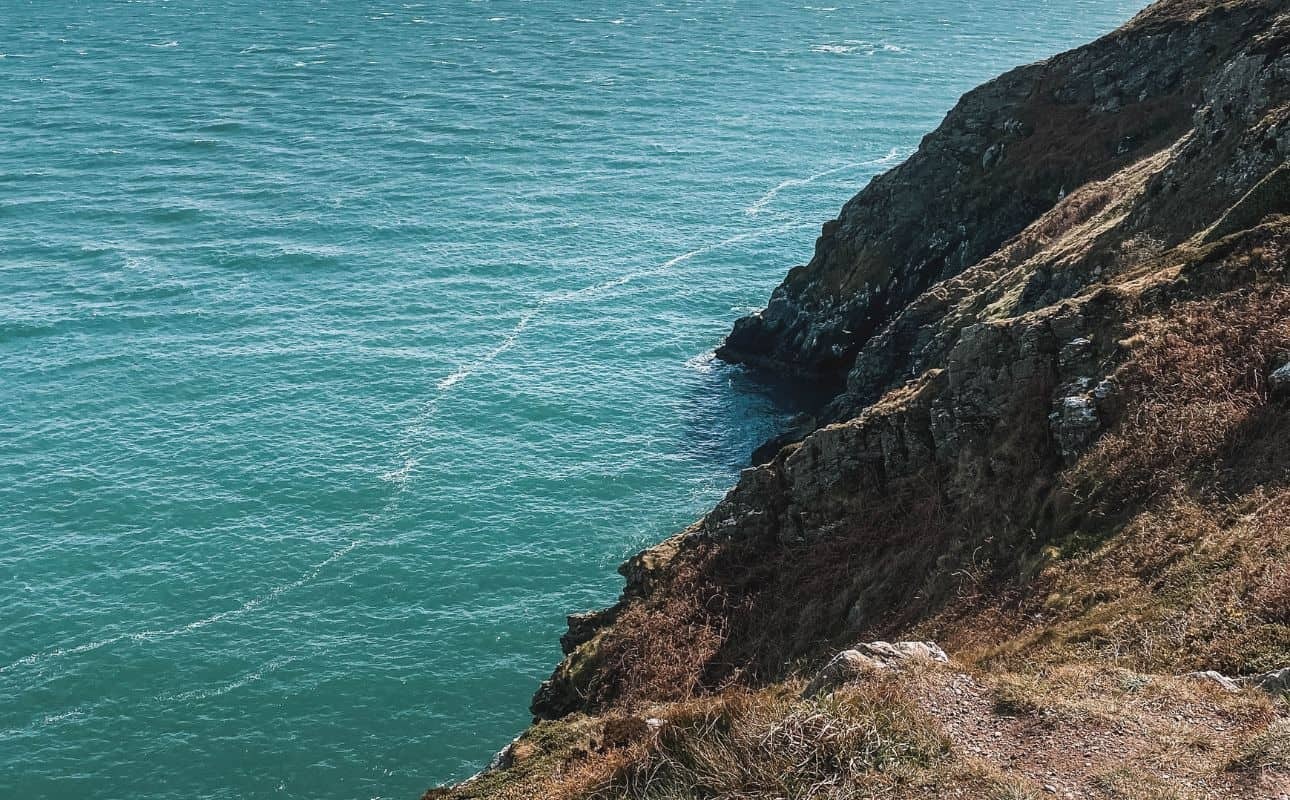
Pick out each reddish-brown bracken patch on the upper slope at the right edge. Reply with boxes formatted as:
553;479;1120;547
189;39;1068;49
1072;286;1290;507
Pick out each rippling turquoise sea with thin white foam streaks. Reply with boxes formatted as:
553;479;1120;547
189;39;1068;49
0;0;1142;800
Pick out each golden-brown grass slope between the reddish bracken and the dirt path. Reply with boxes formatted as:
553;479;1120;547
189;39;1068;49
983;490;1290;675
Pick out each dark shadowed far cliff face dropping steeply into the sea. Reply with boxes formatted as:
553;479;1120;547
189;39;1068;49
717;3;1273;390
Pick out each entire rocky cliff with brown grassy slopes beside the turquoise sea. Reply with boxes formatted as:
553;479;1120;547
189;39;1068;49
432;0;1290;797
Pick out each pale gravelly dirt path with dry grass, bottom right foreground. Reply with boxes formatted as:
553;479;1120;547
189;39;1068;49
911;668;1290;800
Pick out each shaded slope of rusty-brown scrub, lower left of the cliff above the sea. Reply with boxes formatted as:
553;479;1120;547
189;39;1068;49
586;472;957;708
